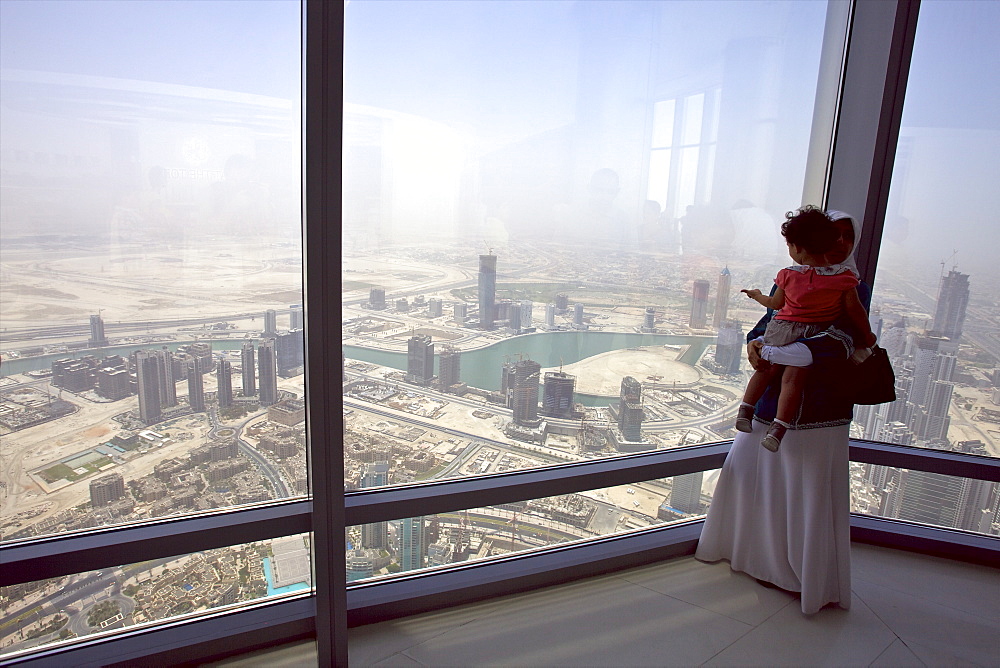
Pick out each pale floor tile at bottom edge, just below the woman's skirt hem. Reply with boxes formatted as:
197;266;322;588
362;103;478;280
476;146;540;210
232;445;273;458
706;597;896;666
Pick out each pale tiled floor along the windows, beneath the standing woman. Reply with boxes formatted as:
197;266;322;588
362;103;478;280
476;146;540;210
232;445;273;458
211;544;1000;667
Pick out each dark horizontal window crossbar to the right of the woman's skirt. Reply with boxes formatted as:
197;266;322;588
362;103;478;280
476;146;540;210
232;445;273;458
851;439;1000;482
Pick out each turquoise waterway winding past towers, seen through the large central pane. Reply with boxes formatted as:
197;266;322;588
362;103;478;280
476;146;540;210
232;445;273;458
344;332;714;394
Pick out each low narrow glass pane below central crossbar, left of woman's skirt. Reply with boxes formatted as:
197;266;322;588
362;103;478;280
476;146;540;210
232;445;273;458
347;469;719;582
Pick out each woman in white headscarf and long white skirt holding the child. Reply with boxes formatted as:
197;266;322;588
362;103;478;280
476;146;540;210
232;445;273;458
695;212;870;614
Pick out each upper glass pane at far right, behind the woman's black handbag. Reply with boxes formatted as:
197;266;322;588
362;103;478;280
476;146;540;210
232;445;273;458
868;0;1000;457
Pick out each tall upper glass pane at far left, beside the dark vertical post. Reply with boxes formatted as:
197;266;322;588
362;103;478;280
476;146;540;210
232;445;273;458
0;1;307;540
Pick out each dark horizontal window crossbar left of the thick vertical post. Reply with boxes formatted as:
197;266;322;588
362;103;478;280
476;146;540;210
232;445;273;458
0;501;312;586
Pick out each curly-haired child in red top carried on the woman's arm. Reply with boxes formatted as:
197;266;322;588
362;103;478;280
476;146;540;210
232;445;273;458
736;206;875;452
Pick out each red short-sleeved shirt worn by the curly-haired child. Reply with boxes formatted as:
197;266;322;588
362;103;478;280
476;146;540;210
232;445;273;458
774;267;858;322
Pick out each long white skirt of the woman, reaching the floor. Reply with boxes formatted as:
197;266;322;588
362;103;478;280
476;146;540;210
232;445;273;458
695;420;851;614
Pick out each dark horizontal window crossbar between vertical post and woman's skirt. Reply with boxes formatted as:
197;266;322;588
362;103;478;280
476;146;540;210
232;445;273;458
345;443;730;526
